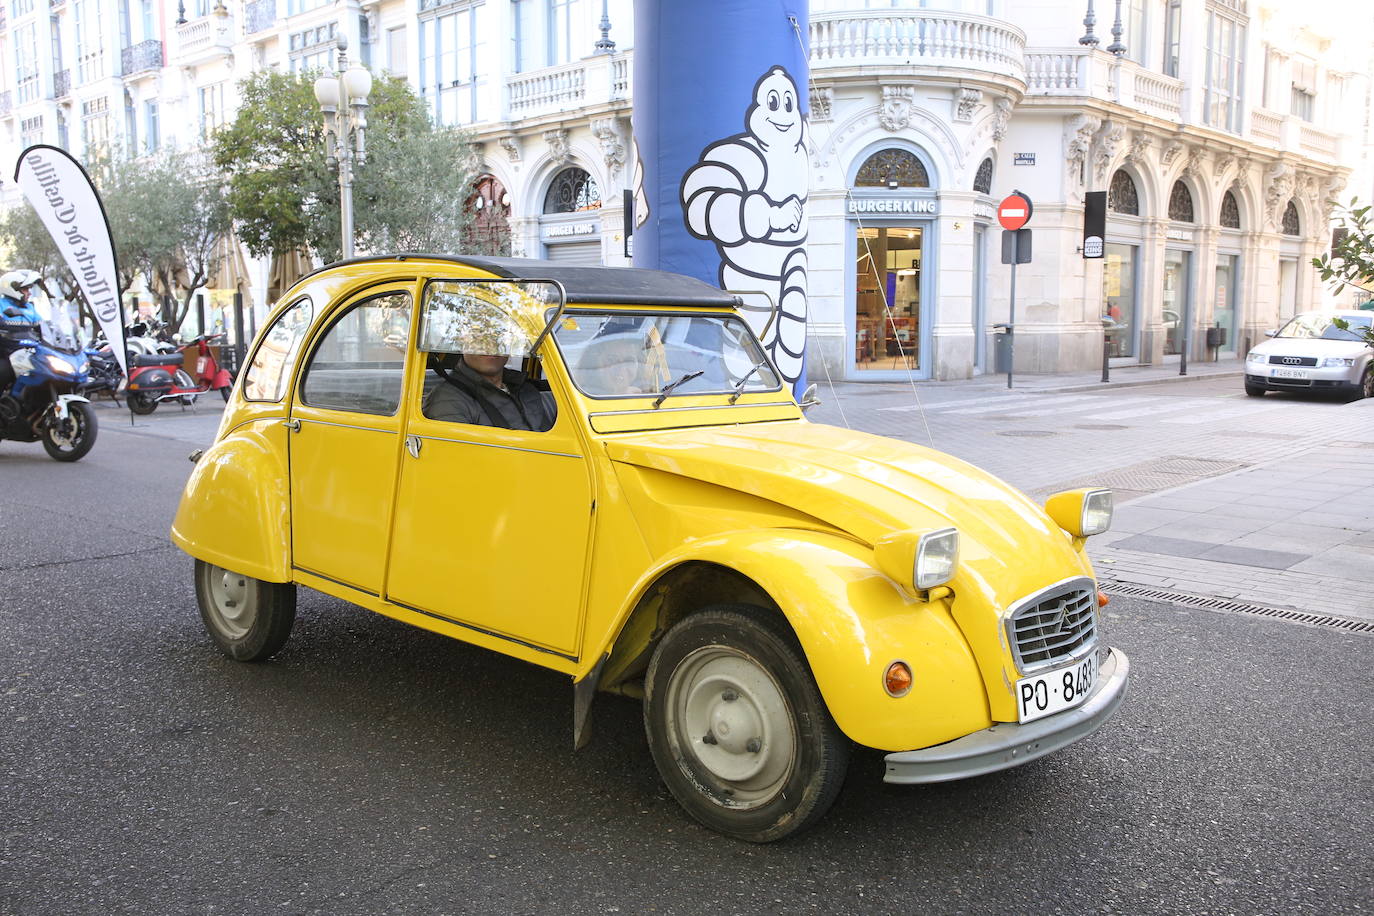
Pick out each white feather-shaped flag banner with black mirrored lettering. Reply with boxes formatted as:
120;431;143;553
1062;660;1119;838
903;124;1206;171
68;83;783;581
14;144;129;375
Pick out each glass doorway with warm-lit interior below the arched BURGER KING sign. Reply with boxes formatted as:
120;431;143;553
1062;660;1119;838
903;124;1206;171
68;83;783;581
855;227;925;369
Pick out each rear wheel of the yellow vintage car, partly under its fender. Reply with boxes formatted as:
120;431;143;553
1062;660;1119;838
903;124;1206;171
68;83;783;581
195;560;295;662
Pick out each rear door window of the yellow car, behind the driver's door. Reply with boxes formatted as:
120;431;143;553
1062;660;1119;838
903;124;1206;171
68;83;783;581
301;293;411;416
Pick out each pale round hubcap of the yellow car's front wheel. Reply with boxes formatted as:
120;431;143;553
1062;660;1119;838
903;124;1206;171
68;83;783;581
666;645;797;808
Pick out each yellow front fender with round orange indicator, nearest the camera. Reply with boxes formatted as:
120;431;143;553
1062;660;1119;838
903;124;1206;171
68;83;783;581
595;529;992;751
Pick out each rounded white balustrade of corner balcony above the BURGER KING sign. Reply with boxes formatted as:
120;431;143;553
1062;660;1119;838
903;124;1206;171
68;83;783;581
811;10;1026;82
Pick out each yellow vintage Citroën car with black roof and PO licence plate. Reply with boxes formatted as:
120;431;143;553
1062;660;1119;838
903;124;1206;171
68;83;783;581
172;255;1129;842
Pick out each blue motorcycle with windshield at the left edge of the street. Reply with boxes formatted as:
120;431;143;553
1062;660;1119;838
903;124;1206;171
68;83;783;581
0;284;96;461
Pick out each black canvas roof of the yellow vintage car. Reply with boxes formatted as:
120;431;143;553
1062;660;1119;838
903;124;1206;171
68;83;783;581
322;253;741;308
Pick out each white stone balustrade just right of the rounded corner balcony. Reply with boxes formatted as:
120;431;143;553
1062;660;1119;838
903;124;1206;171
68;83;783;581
1026;48;1183;121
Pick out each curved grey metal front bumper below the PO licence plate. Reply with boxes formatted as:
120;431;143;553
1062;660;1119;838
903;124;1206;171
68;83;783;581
882;648;1131;783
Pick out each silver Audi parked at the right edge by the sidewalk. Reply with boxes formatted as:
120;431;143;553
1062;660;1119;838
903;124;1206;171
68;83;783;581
1245;310;1374;397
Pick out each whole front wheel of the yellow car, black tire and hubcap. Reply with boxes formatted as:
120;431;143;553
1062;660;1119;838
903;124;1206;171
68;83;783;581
644;604;851;843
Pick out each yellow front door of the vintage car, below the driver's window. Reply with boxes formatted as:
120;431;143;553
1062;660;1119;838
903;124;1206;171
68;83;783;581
386;281;592;659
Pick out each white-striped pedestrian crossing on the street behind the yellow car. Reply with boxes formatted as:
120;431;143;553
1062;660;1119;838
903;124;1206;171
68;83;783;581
878;393;1312;426
